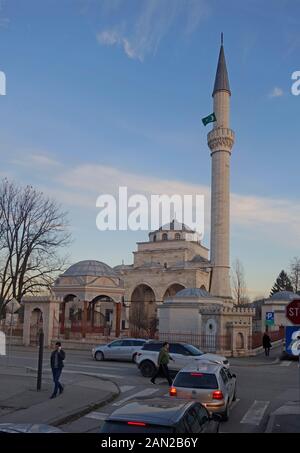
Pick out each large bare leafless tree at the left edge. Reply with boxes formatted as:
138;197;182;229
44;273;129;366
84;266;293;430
0;179;70;313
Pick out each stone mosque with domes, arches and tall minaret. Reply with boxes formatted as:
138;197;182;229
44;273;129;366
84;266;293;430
23;39;254;355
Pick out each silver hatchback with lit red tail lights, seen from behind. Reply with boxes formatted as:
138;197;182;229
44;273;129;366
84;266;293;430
169;362;237;420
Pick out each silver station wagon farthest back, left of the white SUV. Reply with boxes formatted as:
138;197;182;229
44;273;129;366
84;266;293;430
92;338;147;362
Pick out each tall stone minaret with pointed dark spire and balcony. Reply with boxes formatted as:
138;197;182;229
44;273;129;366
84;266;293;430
207;33;234;299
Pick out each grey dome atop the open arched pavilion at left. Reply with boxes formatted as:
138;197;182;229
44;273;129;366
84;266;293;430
62;260;118;277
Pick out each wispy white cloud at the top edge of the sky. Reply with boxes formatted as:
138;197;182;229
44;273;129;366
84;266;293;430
97;0;209;61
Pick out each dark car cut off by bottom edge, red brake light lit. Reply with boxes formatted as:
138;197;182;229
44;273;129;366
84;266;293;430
101;397;221;434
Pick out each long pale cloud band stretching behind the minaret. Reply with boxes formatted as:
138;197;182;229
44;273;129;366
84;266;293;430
5;154;300;246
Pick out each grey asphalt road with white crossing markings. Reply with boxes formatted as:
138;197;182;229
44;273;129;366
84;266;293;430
0;348;299;433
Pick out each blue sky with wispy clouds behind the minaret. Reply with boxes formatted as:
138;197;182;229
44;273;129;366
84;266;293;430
0;0;300;296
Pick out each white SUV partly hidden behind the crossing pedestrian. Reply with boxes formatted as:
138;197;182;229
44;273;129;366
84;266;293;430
136;341;229;377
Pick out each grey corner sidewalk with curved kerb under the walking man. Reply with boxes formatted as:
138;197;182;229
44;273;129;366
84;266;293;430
0;367;120;426
